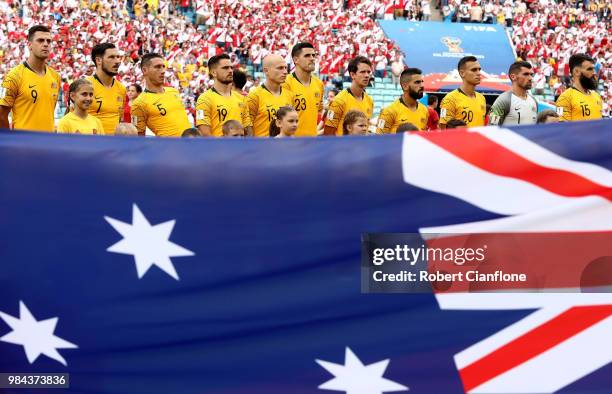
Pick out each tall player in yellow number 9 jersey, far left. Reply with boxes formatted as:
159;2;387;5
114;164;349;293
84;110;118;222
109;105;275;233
0;25;61;132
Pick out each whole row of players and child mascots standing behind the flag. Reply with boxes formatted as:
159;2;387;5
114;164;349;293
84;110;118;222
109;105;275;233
0;25;602;137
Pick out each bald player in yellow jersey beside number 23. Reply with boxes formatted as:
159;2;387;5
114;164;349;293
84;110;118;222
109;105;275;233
247;54;295;137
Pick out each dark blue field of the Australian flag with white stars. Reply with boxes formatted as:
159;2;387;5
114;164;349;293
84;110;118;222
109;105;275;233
0;121;612;394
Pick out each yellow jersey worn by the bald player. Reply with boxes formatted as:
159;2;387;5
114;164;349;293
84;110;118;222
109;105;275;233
247;85;295;137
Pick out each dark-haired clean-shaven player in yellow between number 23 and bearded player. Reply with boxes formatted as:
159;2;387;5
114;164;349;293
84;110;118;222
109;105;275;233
323;56;374;135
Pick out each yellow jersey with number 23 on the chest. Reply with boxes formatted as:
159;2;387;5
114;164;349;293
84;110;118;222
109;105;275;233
283;73;325;137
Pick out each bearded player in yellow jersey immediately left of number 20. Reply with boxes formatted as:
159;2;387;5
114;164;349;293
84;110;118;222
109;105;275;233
376;68;429;134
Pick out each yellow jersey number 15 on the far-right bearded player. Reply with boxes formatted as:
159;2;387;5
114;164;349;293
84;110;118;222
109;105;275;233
557;87;602;122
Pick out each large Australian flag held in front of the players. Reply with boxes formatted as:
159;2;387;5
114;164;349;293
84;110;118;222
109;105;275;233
0;121;612;394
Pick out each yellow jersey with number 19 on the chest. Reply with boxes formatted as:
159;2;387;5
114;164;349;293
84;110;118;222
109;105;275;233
196;88;253;137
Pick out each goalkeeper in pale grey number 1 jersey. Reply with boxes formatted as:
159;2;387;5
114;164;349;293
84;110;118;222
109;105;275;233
489;61;538;125
